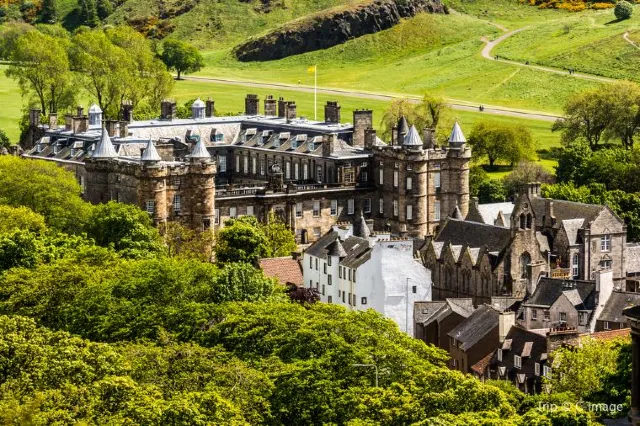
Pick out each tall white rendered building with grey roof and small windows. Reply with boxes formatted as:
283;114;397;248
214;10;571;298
303;218;431;336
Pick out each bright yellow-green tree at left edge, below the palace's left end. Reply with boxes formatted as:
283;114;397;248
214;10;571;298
0;155;90;233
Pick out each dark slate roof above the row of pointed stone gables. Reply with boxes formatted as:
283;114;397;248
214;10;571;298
435;218;511;252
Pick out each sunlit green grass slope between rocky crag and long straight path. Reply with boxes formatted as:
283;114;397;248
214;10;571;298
199;14;594;112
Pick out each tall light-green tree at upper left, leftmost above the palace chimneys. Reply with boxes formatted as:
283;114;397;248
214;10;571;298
6;31;76;115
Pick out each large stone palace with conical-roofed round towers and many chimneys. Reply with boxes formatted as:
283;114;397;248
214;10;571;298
25;95;471;243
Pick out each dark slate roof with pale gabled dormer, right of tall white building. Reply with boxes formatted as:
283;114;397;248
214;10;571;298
525;277;596;310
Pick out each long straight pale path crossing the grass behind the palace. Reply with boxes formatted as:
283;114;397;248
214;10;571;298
182;77;561;122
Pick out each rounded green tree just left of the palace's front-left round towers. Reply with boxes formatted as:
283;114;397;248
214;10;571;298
85;201;162;257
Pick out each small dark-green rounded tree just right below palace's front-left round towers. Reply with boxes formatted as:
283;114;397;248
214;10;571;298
215;216;269;264
